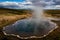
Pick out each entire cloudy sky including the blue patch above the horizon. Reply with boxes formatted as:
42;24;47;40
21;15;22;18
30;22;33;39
0;0;60;9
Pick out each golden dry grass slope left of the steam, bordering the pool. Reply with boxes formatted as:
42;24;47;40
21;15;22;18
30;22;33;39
0;14;31;27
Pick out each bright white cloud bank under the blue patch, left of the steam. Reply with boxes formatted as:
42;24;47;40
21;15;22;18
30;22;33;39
0;1;32;9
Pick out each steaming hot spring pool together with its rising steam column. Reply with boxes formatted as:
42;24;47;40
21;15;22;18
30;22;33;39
3;0;57;39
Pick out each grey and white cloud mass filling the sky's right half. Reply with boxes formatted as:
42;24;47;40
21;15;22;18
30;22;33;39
27;0;60;9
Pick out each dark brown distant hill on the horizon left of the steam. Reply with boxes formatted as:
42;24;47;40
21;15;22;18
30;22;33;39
0;8;31;14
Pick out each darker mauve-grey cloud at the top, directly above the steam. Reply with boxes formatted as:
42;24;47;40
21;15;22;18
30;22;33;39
27;0;55;6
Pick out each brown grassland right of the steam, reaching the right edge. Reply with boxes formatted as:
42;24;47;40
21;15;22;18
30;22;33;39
44;10;60;18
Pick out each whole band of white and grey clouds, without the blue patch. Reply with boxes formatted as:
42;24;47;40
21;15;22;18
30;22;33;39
0;0;60;9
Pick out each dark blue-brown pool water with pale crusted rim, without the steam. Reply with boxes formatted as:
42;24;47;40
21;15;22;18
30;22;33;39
3;19;57;38
